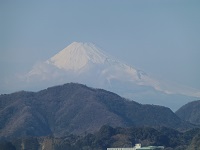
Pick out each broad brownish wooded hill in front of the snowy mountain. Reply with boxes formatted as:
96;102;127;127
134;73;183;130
0;83;194;138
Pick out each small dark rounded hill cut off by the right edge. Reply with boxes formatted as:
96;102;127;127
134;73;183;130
176;100;200;125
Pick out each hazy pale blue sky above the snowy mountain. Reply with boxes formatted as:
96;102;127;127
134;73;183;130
0;0;200;92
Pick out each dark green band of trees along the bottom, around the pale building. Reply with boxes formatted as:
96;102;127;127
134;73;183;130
0;125;200;150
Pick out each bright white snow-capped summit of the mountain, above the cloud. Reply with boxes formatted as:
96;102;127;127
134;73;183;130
47;42;107;71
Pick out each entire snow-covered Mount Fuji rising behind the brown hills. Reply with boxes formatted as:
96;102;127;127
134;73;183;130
22;42;200;110
